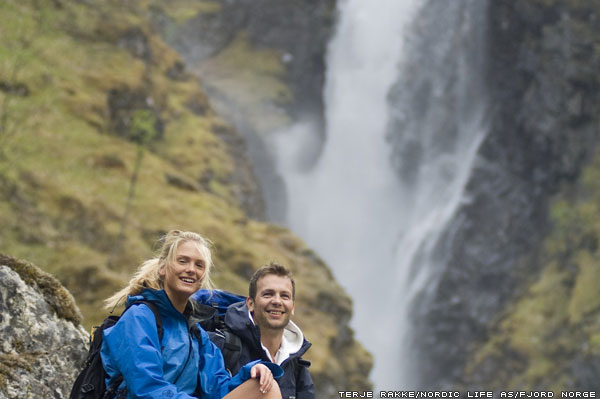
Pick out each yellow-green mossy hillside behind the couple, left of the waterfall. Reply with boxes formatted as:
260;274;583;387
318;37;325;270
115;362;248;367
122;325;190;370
0;0;371;389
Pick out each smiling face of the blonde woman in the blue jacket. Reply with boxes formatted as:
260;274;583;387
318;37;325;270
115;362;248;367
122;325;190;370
159;241;206;311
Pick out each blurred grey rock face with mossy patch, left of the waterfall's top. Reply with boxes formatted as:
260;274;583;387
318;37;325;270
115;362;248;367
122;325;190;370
154;0;336;222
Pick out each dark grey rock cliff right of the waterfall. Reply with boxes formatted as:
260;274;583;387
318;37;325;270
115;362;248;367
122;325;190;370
414;1;600;388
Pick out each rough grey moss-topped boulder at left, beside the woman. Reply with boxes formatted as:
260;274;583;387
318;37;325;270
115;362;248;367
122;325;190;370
0;255;88;399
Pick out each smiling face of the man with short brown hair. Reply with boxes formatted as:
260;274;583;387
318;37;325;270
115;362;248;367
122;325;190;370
246;274;294;330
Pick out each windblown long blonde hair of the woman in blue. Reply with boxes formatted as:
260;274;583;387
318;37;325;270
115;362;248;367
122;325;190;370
104;230;213;309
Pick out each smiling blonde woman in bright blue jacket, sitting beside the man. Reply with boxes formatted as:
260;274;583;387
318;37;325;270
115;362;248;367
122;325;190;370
101;230;281;399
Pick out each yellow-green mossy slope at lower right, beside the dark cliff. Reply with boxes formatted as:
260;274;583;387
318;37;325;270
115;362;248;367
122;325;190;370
466;148;600;395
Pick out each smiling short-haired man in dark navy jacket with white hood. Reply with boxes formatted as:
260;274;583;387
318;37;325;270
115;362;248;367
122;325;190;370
211;263;315;399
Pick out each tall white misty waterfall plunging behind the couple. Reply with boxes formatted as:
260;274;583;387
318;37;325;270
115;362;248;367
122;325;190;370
272;0;486;390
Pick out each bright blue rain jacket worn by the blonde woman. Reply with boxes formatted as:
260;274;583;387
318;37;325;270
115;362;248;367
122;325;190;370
100;289;262;399
